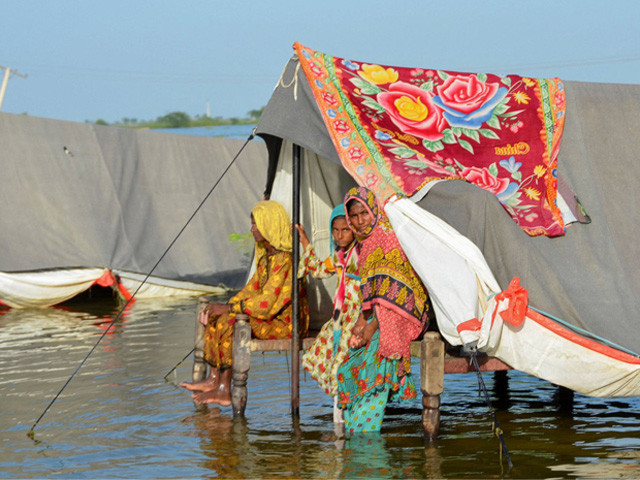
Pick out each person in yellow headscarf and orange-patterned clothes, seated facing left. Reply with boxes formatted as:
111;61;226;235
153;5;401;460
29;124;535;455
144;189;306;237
180;200;309;405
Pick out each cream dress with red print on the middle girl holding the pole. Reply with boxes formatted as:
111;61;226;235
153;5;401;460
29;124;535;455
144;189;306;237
298;242;361;396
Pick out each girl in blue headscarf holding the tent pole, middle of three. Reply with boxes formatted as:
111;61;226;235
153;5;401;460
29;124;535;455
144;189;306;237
296;204;361;430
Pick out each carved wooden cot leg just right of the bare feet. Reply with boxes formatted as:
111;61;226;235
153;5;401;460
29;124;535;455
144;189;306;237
231;313;251;417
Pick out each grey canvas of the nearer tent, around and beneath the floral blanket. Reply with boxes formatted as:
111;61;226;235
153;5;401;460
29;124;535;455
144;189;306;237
257;47;640;395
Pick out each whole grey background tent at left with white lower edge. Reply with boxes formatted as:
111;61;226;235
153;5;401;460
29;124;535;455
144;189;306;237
0;113;267;306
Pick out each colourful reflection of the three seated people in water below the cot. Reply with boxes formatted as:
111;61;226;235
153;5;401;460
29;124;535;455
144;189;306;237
184;407;420;478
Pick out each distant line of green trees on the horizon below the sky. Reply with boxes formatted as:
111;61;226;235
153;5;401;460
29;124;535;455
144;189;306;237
86;107;264;128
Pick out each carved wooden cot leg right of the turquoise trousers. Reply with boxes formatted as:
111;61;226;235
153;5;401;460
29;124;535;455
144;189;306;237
420;332;444;441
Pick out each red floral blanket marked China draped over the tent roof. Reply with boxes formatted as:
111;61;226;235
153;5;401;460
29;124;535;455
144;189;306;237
294;43;565;236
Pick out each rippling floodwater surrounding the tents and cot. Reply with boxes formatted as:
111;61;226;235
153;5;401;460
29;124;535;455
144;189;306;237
0;298;640;479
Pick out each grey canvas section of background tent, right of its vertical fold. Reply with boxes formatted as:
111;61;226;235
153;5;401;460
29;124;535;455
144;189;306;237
90;129;266;287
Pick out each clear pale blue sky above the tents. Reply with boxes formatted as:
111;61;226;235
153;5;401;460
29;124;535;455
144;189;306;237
0;0;640;123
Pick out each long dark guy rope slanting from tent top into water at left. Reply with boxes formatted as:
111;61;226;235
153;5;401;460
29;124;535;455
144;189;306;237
27;128;256;440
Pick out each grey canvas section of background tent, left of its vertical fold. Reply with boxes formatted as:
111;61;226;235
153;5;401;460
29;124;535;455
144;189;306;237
0;114;123;271
